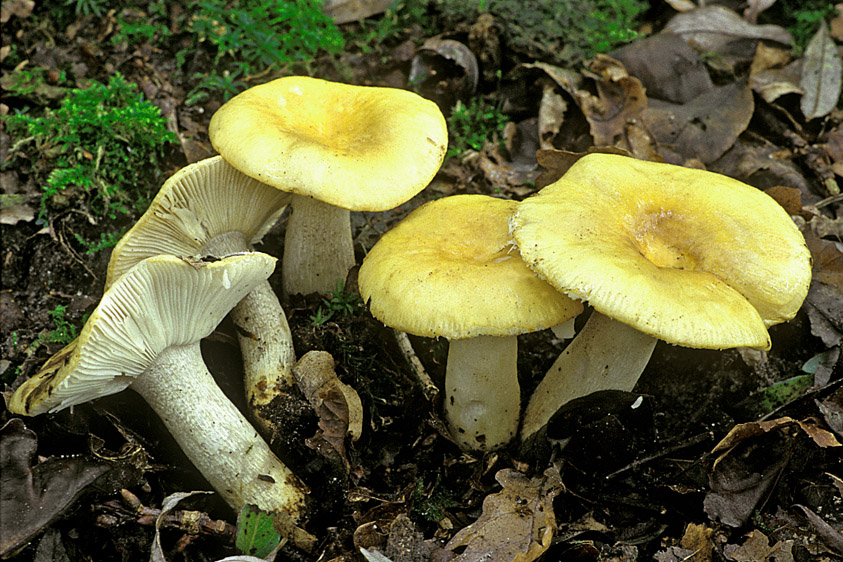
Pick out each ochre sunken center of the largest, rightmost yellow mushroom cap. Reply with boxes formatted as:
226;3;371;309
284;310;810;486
627;207;699;270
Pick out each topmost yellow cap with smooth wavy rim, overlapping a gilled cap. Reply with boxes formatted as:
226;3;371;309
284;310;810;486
209;76;448;211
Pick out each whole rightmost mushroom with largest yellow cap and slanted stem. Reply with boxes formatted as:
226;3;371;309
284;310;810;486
511;154;811;439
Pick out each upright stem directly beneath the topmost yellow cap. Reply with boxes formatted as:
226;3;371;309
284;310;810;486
281;195;355;295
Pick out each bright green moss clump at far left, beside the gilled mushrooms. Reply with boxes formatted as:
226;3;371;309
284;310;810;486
5;74;177;223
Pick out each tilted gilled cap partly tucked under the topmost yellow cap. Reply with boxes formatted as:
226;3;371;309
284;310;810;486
105;156;290;290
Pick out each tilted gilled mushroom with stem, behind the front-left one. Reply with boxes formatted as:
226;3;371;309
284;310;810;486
105;156;296;433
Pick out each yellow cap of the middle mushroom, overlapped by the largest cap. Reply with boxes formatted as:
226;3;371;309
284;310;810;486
358;195;582;339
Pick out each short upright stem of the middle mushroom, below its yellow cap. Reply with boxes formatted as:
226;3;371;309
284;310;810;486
444;336;521;451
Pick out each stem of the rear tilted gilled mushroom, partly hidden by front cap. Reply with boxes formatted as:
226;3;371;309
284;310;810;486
200;232;296;426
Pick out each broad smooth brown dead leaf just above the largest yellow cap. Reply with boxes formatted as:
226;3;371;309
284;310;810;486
641;82;755;164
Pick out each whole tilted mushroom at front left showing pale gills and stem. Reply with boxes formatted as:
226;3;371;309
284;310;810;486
9;253;308;520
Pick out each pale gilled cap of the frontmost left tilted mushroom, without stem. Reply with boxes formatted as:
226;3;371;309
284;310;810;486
9;252;275;416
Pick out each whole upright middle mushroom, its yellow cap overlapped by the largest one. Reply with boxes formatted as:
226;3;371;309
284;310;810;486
358;195;582;451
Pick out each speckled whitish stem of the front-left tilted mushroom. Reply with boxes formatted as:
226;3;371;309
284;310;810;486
132;343;308;520
